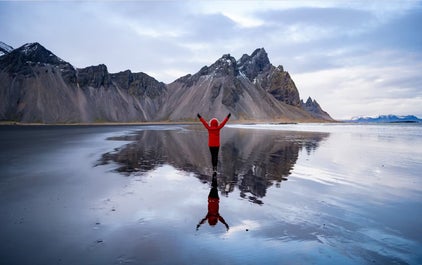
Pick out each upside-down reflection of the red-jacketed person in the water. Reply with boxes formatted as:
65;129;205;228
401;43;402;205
196;172;229;230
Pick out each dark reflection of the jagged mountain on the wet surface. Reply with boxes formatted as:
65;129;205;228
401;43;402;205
100;126;329;204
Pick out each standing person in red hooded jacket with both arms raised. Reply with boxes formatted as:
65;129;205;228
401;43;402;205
198;113;231;171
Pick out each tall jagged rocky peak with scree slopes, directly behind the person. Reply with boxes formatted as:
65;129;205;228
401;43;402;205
158;48;332;121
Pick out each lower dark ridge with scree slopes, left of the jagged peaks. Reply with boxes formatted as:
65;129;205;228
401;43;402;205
0;43;167;123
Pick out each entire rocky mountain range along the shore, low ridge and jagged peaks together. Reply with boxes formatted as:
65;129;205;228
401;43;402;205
0;43;332;123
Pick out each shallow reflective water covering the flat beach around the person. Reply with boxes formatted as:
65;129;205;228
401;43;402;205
0;124;422;264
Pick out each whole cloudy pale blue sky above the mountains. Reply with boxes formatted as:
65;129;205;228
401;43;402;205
0;0;422;119
